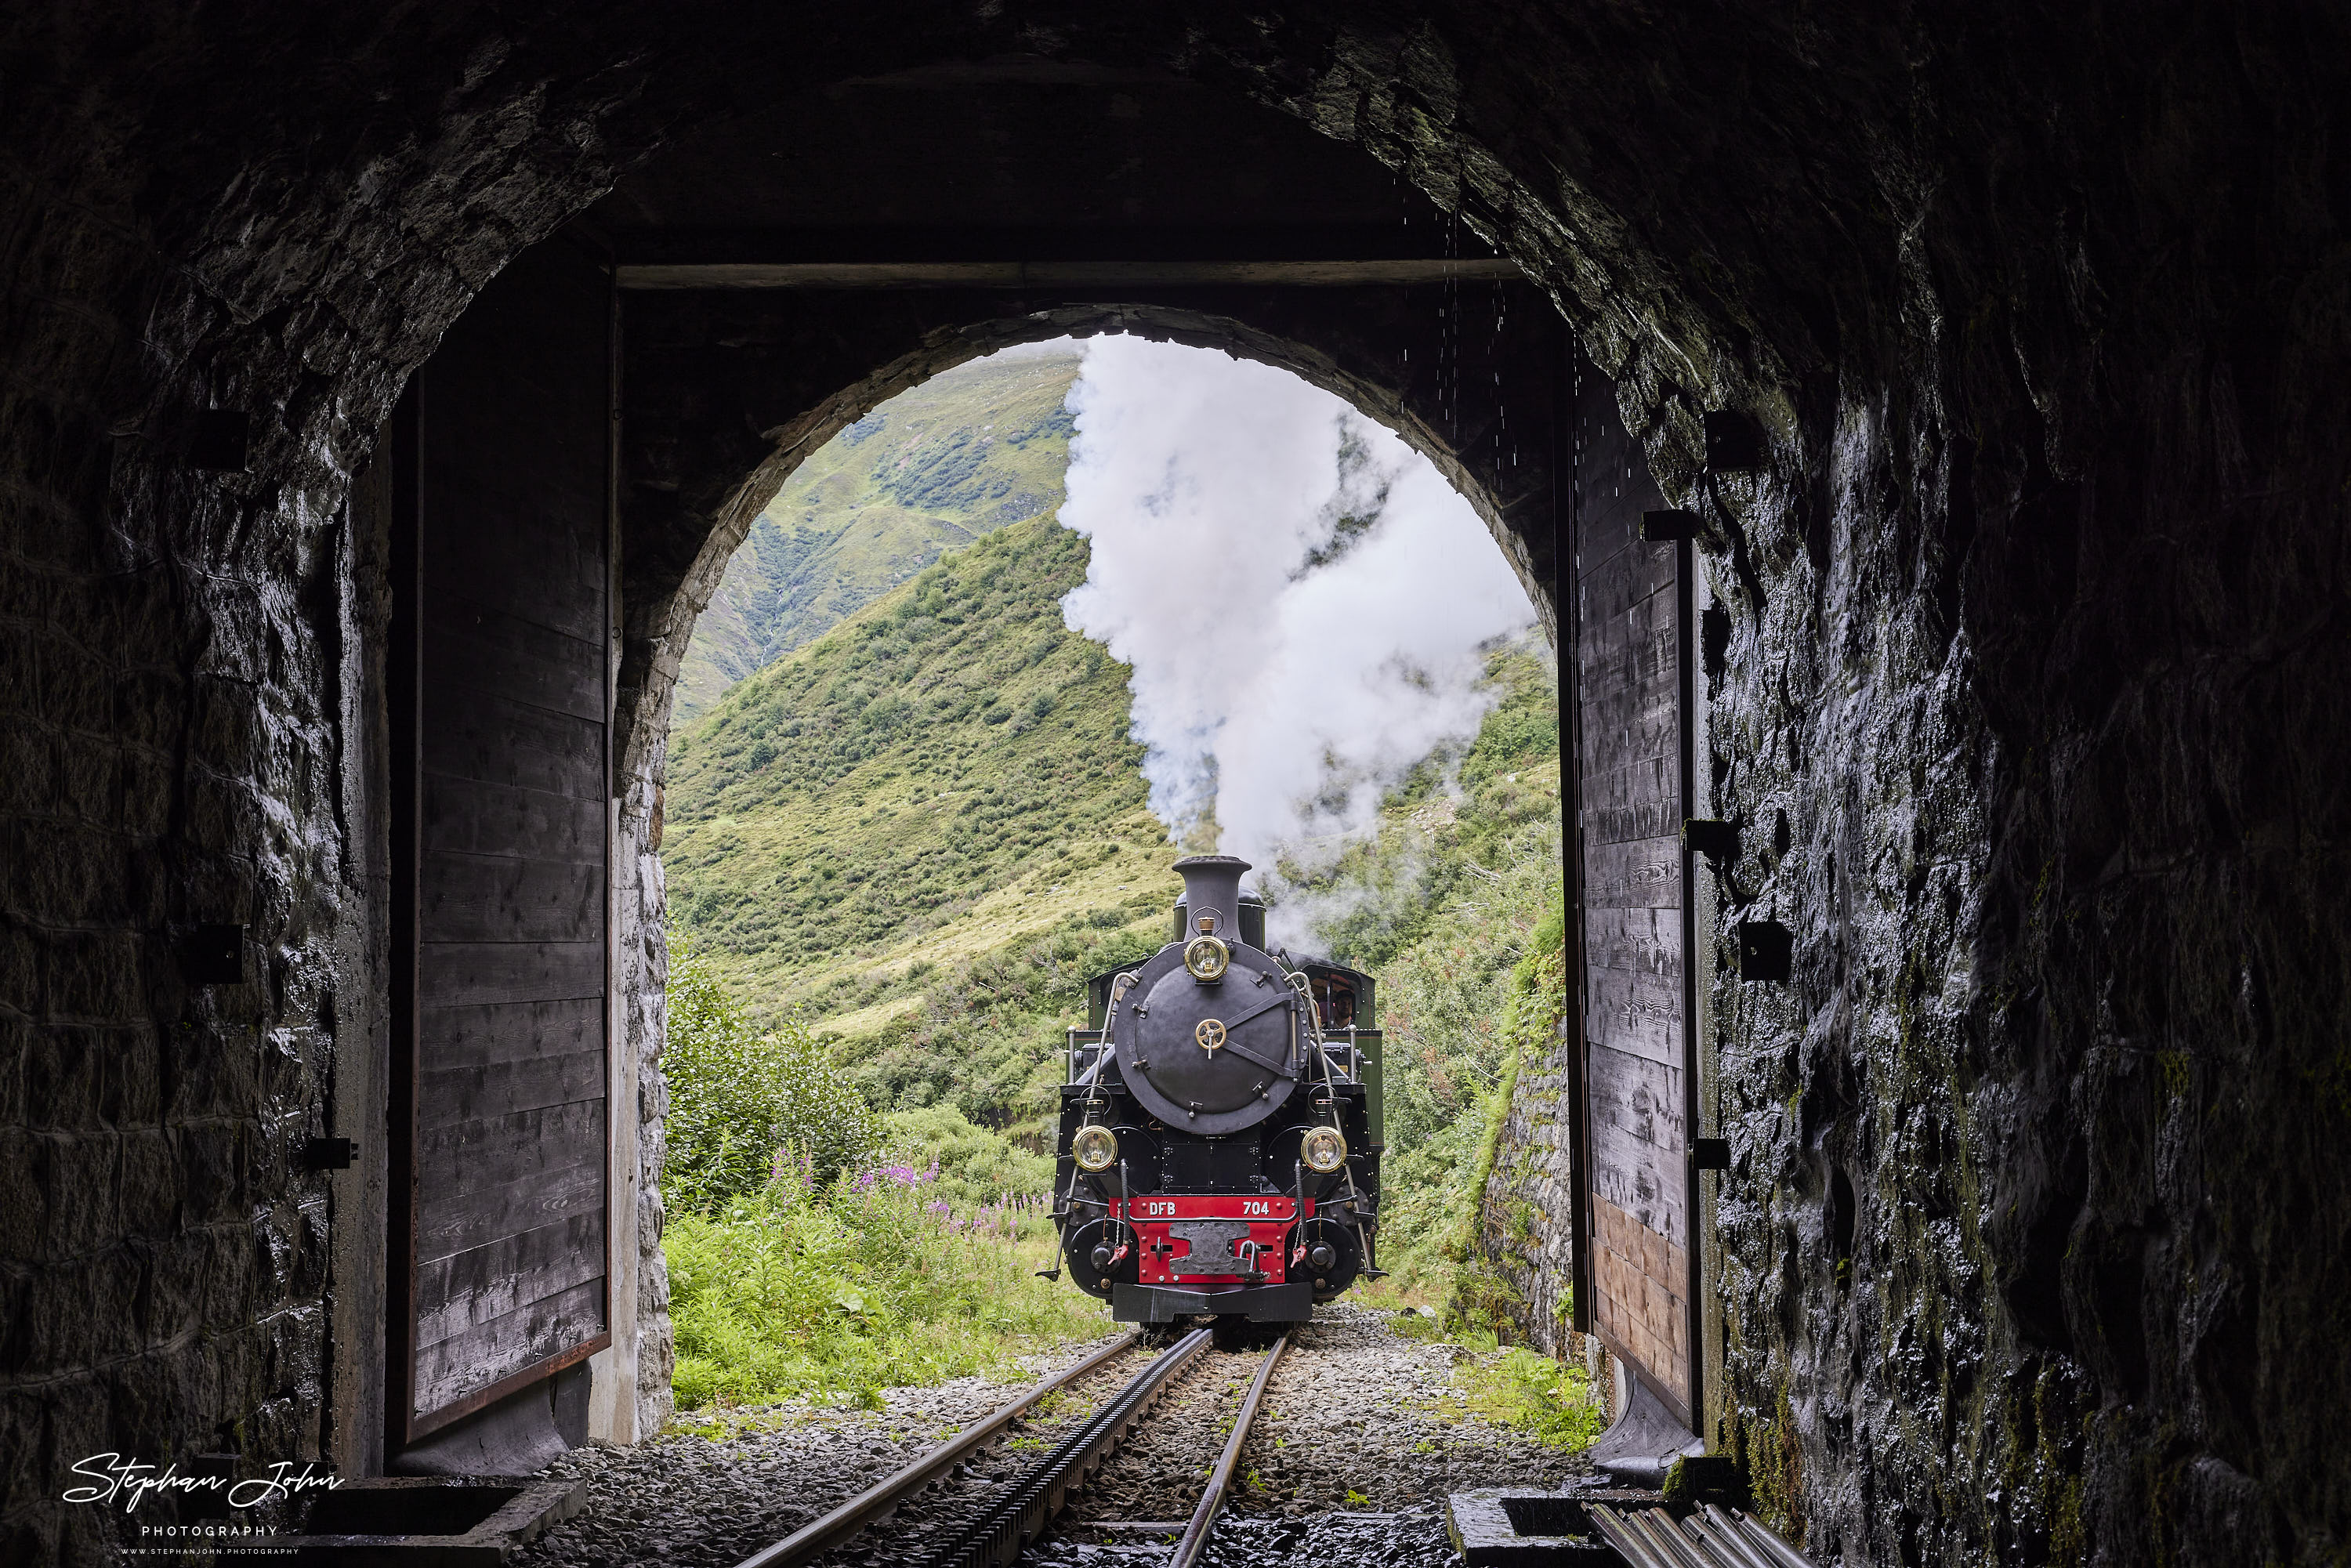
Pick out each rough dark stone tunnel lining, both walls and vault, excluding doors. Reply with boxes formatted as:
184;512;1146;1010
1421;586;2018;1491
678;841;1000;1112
0;2;2351;1561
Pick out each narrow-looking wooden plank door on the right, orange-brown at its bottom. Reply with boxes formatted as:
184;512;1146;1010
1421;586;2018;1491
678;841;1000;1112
1575;367;1697;1427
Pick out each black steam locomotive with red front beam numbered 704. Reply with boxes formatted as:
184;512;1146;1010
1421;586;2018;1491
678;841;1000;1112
1049;856;1382;1326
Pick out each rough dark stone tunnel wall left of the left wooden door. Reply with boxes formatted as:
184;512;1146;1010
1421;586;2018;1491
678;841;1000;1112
0;18;654;1563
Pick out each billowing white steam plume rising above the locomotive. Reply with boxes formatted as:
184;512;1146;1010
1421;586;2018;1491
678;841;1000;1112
1060;336;1535;931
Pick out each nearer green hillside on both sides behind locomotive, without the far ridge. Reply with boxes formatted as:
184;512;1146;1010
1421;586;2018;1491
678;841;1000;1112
663;496;1559;1171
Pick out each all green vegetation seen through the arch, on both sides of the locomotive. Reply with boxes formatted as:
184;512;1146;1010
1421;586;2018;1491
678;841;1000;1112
663;357;1582;1382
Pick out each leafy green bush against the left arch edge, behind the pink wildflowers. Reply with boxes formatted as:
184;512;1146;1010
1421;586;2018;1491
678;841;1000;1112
661;947;879;1213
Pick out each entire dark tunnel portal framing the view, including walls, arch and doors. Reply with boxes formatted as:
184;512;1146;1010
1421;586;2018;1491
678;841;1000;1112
0;12;2351;1563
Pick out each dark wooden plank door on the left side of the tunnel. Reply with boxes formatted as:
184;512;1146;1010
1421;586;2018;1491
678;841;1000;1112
393;244;611;1441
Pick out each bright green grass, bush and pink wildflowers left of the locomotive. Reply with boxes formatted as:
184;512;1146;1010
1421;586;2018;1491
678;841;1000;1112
663;931;1107;1410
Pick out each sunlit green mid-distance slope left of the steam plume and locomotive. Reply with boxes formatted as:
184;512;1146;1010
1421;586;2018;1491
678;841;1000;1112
663;517;1180;1126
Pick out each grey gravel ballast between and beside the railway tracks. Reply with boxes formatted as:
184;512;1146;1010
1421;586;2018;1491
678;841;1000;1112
513;1302;1587;1568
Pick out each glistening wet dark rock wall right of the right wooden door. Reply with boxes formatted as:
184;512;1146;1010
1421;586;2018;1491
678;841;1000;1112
1260;16;2351;1563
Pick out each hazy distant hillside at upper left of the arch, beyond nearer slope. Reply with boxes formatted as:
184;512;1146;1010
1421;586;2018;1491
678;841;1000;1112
675;350;1079;729
